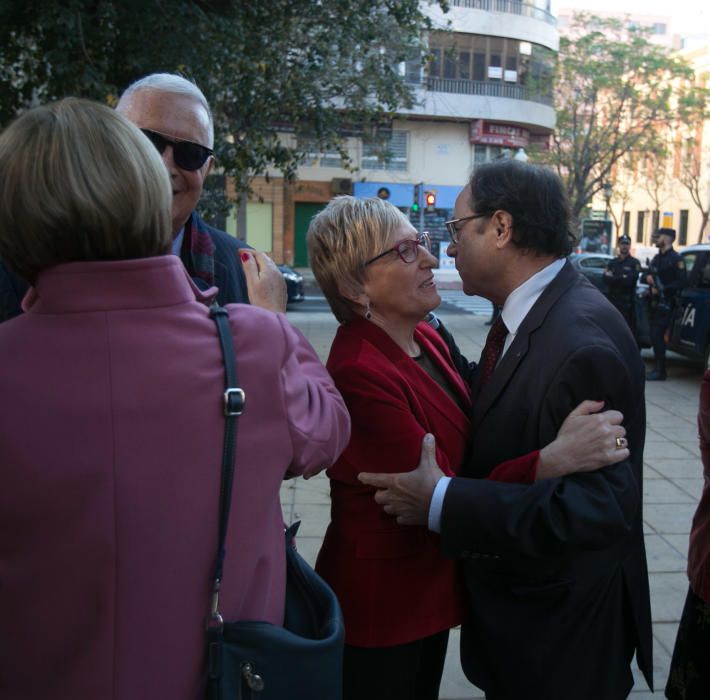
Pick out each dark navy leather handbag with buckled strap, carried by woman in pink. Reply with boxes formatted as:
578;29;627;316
207;304;345;700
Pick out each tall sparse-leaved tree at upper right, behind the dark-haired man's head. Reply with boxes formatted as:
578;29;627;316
537;14;704;221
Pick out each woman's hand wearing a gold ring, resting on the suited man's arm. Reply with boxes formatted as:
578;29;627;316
536;401;630;481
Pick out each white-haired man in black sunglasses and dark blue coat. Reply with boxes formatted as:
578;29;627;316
0;73;249;321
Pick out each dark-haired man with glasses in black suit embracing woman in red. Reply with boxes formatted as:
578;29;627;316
363;160;652;700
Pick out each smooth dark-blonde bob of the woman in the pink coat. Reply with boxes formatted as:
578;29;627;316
0;98;172;284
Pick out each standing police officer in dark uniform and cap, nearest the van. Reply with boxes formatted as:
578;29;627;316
646;228;685;381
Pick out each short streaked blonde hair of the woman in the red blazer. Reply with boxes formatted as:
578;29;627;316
307;195;409;323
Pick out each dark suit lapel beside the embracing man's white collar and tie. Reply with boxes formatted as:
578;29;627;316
473;261;578;432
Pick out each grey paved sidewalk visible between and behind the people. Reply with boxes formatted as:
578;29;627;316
281;311;703;700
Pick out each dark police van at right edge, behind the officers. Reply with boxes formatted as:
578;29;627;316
668;244;710;367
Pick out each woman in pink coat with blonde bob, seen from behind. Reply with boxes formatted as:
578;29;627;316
0;99;349;700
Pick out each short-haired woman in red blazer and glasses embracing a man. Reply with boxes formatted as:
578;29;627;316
308;197;632;700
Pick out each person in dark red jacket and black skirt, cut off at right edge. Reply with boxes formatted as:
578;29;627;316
666;369;710;700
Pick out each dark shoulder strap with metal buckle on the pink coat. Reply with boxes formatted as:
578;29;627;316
208;302;246;627
